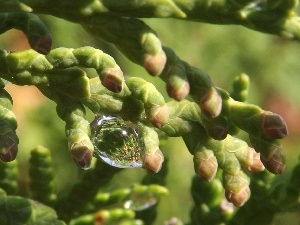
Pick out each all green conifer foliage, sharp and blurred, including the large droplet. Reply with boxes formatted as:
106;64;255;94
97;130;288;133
0;0;300;225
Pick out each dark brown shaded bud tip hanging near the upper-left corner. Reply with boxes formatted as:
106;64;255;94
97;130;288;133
29;33;52;54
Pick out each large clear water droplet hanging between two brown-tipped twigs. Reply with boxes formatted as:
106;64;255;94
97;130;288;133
91;116;145;168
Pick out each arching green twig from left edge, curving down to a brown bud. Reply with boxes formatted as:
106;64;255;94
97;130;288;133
0;47;124;92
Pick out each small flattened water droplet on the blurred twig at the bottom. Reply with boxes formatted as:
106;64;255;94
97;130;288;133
124;192;157;211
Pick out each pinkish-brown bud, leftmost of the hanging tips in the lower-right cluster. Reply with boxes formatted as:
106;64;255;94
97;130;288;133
194;149;218;181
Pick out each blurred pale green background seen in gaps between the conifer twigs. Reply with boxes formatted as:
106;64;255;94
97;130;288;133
0;16;300;225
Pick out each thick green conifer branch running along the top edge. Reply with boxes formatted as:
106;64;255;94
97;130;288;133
12;0;299;40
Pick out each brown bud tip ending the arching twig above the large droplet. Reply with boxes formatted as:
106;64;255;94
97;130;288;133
101;66;124;93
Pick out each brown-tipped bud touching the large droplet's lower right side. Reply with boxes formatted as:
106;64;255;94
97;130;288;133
144;148;164;173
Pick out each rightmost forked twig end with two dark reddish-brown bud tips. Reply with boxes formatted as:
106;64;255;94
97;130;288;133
230;96;288;174
